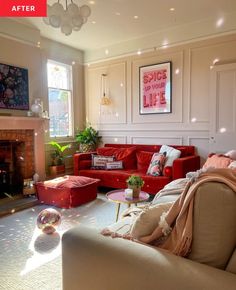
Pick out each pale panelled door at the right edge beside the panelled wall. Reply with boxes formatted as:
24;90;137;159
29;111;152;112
209;63;236;153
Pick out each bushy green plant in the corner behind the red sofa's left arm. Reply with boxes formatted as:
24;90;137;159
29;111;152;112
76;125;102;152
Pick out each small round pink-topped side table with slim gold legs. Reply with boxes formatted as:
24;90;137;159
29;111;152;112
106;189;149;222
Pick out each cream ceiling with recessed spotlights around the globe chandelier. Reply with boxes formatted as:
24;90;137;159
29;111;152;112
12;0;236;61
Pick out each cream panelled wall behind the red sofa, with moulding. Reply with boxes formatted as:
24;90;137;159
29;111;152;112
85;35;236;162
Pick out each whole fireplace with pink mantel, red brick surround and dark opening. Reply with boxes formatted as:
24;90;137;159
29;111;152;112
0;116;47;198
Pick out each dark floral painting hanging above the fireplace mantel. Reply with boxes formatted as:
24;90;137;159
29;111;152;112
0;63;29;111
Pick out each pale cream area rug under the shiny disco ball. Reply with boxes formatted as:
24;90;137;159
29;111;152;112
0;194;129;290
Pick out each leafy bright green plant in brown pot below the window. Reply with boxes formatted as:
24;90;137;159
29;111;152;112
49;141;70;176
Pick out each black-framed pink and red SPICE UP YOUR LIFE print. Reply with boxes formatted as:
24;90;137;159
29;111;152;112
139;61;172;115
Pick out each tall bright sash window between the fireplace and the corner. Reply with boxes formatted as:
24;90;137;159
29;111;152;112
47;60;73;137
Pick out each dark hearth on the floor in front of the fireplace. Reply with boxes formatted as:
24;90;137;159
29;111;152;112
0;194;39;217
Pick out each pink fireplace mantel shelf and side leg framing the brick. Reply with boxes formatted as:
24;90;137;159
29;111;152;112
0;116;48;180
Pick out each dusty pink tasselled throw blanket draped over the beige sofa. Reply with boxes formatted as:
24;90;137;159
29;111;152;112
101;168;236;256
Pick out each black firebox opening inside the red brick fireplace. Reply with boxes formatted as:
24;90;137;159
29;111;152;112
0;140;25;198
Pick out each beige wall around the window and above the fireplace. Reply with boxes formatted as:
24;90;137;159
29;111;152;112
0;32;85;176
